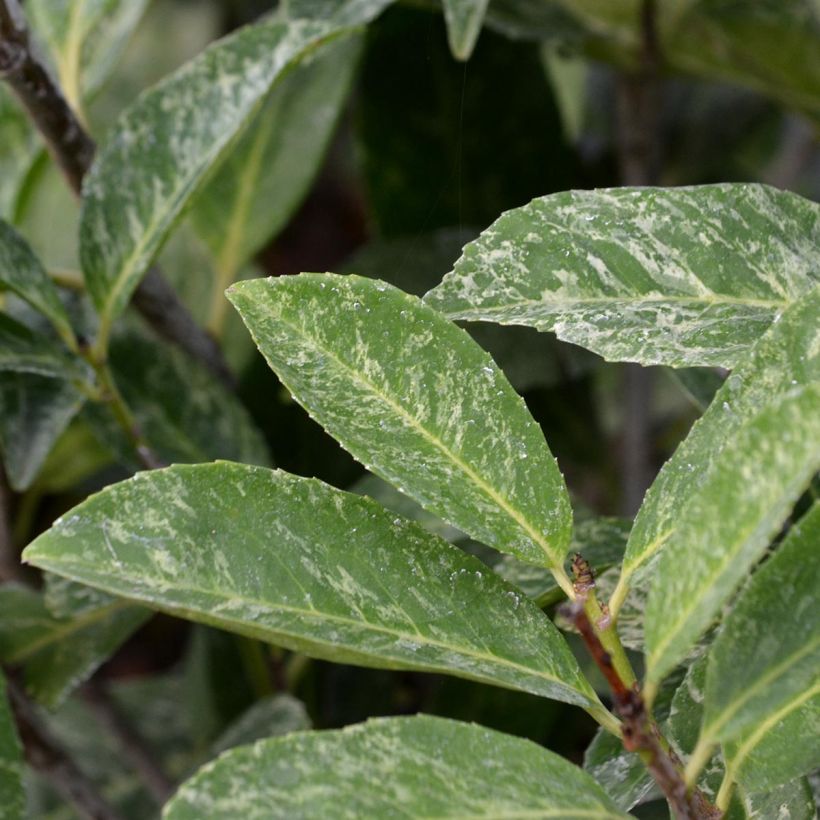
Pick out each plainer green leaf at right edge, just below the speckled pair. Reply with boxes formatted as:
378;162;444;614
700;504;820;743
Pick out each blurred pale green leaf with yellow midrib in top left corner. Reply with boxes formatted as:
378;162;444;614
26;0;148;111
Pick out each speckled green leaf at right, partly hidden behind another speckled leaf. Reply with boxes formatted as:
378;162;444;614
610;288;820;614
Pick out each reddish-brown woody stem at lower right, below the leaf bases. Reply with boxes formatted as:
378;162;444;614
562;599;723;820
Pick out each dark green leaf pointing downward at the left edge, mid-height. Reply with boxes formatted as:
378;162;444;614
0;371;84;492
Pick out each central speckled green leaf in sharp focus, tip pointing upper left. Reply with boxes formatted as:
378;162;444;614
228;274;572;574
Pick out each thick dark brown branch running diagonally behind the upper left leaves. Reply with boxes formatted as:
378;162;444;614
0;0;236;388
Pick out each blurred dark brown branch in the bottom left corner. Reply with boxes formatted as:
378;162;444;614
7;679;125;820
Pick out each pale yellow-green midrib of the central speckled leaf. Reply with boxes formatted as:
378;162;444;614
266;306;566;572
